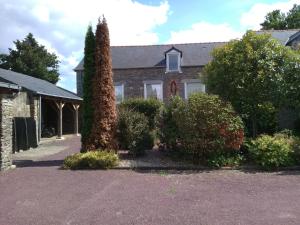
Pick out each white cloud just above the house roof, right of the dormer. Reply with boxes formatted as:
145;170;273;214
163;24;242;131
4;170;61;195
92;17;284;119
167;22;243;43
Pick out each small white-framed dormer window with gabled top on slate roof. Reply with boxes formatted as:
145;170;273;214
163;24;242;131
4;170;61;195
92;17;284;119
165;47;182;72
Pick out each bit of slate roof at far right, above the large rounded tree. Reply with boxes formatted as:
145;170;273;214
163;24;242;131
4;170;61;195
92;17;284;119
256;29;300;45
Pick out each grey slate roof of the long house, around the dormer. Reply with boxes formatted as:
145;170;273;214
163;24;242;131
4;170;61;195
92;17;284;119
74;42;225;71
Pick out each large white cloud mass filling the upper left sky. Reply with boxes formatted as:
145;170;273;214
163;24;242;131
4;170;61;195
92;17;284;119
0;0;169;90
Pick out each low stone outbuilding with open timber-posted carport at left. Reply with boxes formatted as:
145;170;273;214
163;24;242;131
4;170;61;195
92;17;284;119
0;69;82;170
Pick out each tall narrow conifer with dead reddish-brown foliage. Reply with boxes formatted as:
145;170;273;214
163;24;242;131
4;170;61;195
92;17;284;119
91;18;117;150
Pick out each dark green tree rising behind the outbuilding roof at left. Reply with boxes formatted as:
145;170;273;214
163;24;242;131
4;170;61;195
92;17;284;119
0;33;59;84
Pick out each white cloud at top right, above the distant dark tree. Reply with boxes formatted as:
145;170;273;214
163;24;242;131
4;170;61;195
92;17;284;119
240;0;300;30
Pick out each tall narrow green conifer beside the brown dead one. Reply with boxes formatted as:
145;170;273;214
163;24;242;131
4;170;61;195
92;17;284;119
81;26;96;151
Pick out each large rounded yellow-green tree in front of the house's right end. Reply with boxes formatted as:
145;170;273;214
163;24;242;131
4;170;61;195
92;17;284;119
205;31;300;136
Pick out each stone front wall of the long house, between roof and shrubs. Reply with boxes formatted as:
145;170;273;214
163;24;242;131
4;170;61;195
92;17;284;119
77;66;203;102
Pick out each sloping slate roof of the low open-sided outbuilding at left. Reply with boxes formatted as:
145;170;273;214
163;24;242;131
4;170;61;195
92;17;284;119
0;68;82;100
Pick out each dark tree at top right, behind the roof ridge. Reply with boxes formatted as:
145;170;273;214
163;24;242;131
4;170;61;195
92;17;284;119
260;4;300;30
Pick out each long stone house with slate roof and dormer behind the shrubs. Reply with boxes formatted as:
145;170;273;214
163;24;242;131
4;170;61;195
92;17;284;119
74;30;300;102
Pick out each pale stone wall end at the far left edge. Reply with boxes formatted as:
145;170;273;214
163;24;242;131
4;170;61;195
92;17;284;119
0;94;13;170
